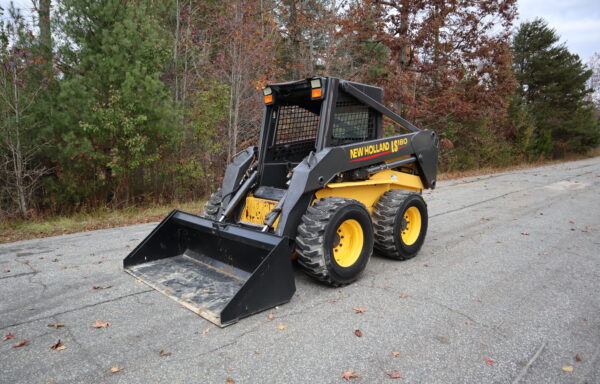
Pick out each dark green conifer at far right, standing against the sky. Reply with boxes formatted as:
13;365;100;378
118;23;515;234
512;19;600;157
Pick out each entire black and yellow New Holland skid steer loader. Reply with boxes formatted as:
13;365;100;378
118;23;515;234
124;77;439;326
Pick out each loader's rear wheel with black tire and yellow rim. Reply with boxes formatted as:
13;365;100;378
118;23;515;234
373;189;428;260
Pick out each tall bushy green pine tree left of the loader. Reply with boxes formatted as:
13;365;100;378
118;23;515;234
55;0;177;204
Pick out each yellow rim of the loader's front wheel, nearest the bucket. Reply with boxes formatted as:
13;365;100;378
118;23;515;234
332;219;364;267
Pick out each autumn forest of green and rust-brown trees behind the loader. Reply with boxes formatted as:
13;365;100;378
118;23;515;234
0;0;600;222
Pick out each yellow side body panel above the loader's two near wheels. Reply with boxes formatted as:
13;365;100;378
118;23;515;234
316;170;424;212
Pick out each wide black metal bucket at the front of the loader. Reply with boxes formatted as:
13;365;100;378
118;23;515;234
123;210;296;327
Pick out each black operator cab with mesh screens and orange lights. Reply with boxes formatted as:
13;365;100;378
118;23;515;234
255;77;383;192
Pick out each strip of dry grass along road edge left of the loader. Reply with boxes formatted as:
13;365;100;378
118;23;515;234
0;201;204;244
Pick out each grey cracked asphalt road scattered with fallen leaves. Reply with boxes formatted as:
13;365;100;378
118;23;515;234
0;158;600;384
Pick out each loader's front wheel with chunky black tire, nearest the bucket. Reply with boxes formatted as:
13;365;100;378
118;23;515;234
296;197;373;287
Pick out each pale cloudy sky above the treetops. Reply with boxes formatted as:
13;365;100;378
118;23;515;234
0;0;600;62
